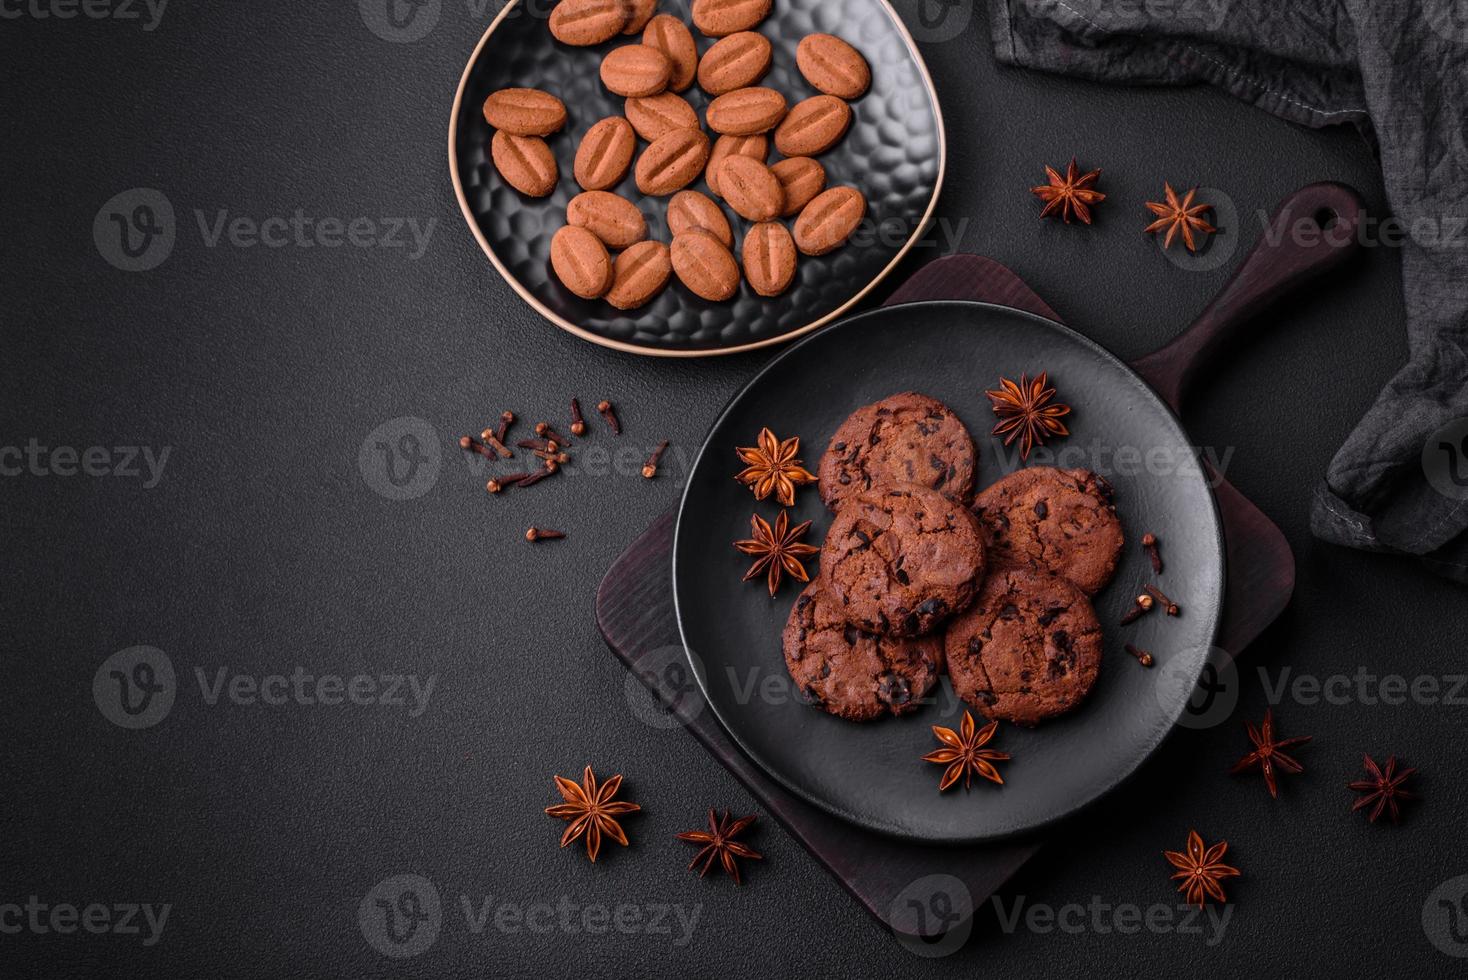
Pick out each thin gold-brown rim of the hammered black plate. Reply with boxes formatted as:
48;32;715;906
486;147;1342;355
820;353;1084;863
449;0;948;358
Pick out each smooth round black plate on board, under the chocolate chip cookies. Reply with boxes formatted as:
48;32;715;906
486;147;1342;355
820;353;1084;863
672;302;1224;842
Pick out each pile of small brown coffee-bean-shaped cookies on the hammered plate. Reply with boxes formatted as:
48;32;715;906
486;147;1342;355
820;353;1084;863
484;0;872;310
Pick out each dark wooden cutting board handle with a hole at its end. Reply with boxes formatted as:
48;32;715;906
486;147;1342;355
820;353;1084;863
1132;183;1365;409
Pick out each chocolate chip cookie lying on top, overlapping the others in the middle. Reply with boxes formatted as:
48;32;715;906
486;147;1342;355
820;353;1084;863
821;484;985;637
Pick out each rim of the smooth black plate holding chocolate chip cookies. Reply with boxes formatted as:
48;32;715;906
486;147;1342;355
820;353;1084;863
669;299;1229;846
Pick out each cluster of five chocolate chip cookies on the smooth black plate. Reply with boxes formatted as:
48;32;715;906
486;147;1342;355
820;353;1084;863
782;392;1124;725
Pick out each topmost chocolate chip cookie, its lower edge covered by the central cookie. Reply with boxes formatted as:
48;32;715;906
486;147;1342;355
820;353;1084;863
818;392;979;511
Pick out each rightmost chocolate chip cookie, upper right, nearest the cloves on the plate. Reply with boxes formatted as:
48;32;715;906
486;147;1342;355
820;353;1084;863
973;467;1126;594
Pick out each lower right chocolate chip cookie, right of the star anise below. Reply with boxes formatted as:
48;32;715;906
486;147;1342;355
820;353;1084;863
944;568;1101;725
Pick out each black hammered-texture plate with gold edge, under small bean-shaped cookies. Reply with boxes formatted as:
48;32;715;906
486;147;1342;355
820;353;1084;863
449;0;944;356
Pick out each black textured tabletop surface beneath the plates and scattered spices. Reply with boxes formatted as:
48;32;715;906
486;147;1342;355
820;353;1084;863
0;0;1468;977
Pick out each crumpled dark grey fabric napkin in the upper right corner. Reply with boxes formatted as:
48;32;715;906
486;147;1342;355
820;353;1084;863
989;0;1468;582
